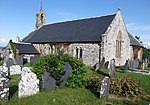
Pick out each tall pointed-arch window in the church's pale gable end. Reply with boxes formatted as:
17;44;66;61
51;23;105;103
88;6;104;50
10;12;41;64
116;31;122;58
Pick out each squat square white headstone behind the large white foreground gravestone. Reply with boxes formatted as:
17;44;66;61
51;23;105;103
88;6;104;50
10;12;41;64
9;65;21;75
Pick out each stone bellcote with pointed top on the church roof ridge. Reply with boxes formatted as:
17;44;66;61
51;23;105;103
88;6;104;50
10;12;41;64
35;2;46;29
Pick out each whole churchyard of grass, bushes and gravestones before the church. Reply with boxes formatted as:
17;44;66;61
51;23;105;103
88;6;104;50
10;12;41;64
0;55;150;105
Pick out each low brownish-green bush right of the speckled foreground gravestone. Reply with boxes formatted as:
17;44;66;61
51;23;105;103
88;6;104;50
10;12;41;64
110;78;141;97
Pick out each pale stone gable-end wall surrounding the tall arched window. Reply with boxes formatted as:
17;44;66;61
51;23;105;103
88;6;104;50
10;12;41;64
101;11;130;66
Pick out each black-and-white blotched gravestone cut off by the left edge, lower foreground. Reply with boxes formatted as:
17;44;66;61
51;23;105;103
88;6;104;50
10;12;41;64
0;71;9;100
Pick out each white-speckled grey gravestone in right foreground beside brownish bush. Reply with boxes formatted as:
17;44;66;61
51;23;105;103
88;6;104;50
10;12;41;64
100;76;110;98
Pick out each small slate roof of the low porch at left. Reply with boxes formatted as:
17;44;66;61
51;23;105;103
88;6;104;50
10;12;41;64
14;43;39;54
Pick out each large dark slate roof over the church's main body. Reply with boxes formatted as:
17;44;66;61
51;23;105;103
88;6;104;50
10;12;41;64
22;14;116;44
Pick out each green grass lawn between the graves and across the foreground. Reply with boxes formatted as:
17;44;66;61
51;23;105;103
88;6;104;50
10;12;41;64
0;69;150;105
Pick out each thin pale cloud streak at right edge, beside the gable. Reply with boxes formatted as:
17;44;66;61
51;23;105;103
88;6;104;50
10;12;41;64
126;23;150;31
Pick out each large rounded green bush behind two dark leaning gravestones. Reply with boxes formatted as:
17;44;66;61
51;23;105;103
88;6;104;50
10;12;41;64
32;54;87;88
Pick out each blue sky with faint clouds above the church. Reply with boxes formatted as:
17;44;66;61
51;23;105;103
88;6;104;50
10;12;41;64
0;0;150;46
